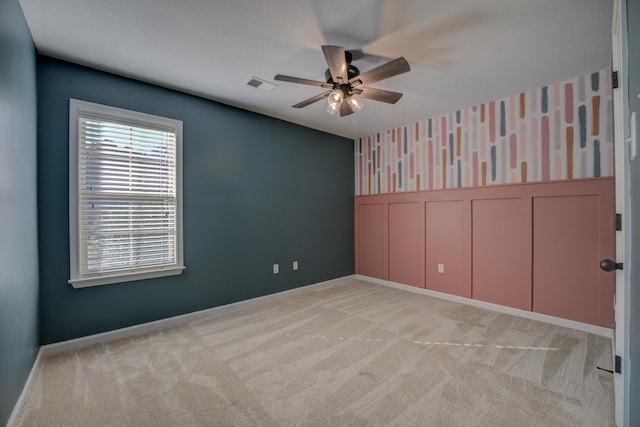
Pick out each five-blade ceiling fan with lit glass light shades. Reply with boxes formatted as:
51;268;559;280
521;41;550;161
274;45;411;117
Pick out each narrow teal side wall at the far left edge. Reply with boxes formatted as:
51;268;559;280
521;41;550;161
0;0;38;425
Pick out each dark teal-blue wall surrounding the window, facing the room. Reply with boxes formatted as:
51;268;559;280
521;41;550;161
38;57;355;344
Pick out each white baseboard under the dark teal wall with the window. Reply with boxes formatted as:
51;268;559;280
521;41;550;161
40;275;355;356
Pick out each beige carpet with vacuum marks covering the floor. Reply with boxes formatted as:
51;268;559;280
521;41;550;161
18;279;613;427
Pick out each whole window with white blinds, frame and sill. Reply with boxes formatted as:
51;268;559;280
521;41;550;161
69;99;184;288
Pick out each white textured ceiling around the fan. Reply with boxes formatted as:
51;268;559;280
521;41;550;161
20;0;613;138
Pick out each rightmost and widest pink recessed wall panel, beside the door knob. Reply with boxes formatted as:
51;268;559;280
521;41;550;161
533;194;613;327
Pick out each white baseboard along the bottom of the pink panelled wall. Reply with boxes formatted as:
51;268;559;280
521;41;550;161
355;274;613;338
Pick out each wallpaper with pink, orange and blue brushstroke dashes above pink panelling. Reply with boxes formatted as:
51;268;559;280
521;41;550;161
354;69;613;195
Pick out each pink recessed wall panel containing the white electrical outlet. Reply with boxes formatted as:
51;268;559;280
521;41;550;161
425;200;464;297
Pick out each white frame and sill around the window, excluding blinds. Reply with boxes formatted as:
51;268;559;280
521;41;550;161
68;98;185;288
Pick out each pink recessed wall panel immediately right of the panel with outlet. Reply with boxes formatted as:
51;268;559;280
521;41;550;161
472;198;531;310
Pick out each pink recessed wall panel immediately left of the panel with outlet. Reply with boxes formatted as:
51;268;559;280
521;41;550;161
389;202;424;287
